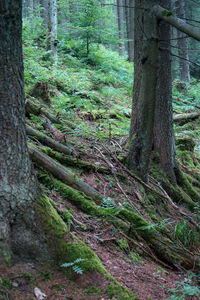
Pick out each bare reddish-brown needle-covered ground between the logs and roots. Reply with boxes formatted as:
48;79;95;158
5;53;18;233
0;102;199;300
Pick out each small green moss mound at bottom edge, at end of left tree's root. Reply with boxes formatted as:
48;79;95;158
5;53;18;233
107;284;138;300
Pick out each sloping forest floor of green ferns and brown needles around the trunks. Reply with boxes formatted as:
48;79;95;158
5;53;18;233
0;49;200;300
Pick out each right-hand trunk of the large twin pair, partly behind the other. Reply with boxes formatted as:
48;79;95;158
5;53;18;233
154;0;176;182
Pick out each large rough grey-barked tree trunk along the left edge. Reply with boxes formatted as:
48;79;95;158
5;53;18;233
0;0;45;258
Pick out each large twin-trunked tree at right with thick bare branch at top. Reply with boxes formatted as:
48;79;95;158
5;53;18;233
128;0;200;182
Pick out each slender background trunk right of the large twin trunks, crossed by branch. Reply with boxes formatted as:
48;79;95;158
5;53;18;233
175;0;190;82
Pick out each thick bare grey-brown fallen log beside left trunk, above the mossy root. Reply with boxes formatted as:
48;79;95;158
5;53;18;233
29;146;102;201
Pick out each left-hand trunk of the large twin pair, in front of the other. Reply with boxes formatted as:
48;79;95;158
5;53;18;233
128;0;158;180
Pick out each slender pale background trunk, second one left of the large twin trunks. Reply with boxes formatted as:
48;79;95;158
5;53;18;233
117;0;124;55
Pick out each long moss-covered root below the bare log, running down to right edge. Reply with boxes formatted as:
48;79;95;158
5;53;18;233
41;171;199;269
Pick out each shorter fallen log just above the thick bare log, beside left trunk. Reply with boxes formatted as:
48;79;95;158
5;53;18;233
26;126;77;156
